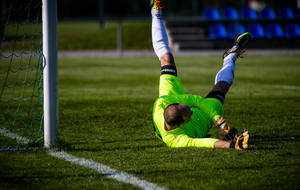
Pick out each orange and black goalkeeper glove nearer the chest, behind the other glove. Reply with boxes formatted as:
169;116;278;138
215;117;240;142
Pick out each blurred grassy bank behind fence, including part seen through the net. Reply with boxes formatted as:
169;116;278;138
2;21;152;52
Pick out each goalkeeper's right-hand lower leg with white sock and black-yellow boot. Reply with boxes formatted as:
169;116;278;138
207;32;251;103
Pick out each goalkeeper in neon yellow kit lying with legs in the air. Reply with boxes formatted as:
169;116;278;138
151;0;251;150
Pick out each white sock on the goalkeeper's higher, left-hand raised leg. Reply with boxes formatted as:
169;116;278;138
151;9;172;60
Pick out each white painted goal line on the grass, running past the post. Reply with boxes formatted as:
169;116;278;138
0;128;167;190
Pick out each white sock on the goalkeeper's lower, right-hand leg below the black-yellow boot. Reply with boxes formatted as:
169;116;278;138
215;53;237;86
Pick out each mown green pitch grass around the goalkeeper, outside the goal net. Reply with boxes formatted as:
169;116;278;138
0;55;300;190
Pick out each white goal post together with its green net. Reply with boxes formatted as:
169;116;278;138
0;0;59;148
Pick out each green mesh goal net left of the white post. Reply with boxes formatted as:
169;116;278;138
0;0;43;149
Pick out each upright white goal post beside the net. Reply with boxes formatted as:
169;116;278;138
42;0;59;147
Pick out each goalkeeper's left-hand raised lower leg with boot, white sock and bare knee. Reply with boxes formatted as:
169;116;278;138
150;0;176;70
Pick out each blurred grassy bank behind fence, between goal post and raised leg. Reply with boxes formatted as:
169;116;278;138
58;22;152;50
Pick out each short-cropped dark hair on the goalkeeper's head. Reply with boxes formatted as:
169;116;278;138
164;103;184;127
